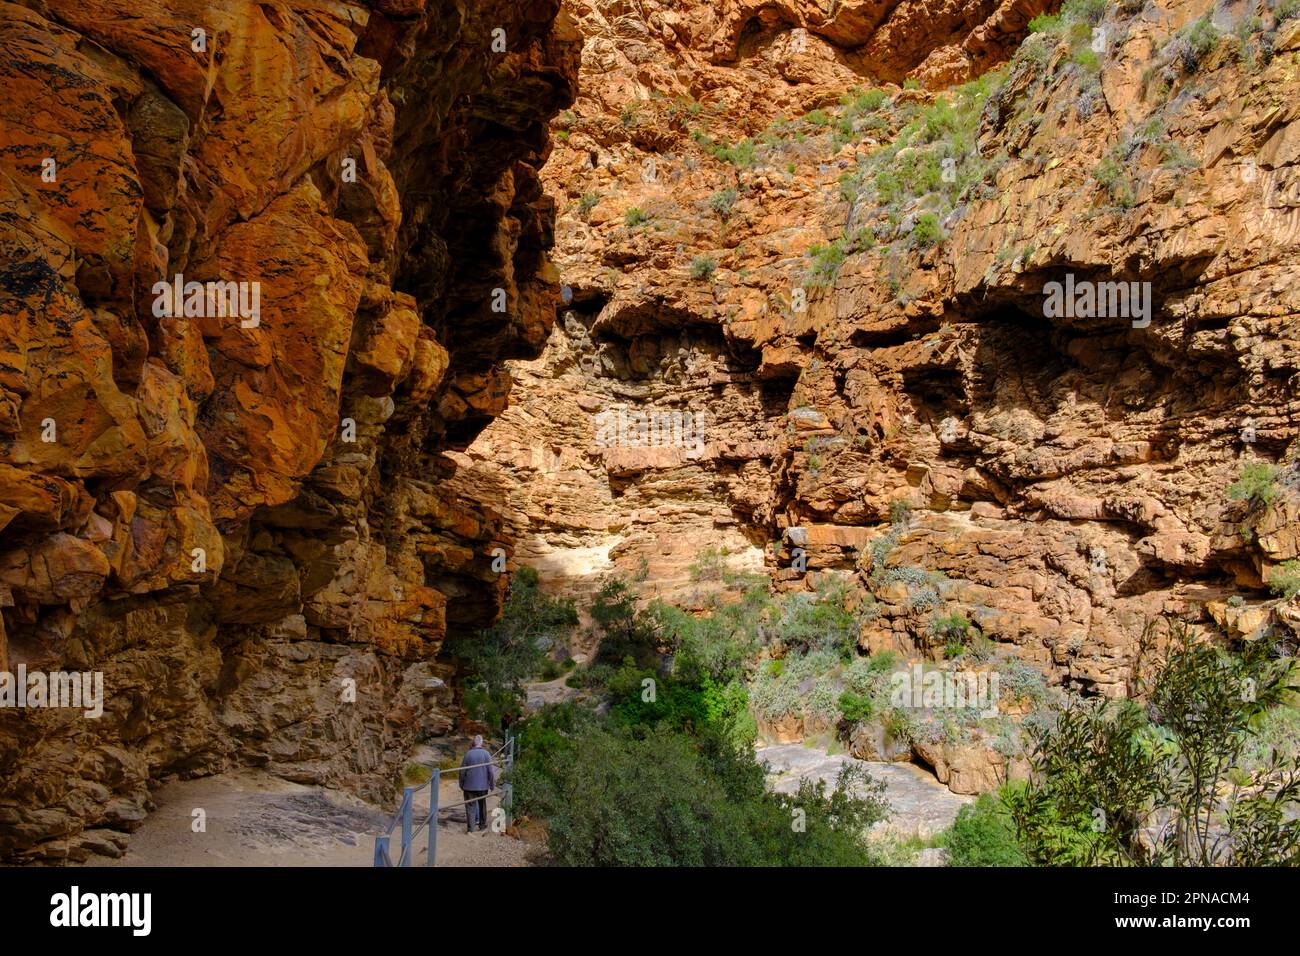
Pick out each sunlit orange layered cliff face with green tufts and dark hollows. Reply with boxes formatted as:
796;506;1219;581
468;0;1300;743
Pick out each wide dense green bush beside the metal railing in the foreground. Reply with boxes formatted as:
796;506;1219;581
515;705;888;866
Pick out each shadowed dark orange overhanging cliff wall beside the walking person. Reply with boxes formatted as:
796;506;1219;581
0;0;581;860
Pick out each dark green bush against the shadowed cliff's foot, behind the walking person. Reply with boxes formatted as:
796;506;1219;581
460;567;577;728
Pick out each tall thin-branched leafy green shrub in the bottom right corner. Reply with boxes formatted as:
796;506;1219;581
1008;620;1300;866
